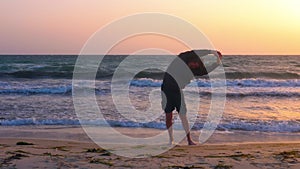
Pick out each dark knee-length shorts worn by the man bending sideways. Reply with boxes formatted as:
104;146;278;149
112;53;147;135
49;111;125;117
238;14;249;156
161;90;186;113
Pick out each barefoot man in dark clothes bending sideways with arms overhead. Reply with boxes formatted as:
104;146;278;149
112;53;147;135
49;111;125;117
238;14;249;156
161;50;222;145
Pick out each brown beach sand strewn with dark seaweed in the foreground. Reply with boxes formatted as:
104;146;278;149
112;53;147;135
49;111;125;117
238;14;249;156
0;127;300;169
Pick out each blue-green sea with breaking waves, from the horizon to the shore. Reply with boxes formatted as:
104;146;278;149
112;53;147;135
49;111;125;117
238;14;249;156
0;55;300;133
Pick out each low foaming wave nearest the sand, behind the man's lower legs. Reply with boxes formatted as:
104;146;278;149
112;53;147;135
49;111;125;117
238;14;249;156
0;118;300;132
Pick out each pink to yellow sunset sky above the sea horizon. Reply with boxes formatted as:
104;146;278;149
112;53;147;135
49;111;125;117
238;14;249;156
0;0;300;55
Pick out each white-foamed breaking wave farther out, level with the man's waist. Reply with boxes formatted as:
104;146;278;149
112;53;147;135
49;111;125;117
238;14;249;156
0;78;300;97
